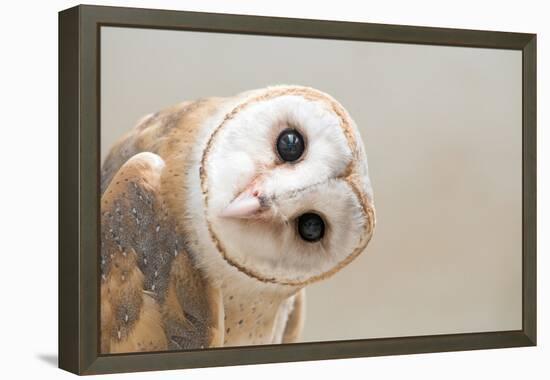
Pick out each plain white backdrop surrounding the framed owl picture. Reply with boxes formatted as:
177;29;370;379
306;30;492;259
0;0;550;379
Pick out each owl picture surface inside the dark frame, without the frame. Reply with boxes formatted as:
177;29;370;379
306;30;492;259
98;27;521;353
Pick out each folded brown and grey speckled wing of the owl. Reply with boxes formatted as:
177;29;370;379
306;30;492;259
100;152;223;353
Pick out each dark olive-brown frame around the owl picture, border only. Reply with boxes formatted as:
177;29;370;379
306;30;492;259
59;5;536;374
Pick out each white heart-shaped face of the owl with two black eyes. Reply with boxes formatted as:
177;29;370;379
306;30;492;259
200;87;374;285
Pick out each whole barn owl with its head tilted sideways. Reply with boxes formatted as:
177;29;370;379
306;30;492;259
100;86;375;353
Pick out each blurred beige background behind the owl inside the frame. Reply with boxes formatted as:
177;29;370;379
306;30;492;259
101;27;521;341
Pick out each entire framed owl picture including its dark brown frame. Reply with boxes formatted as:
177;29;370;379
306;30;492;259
59;6;536;374
